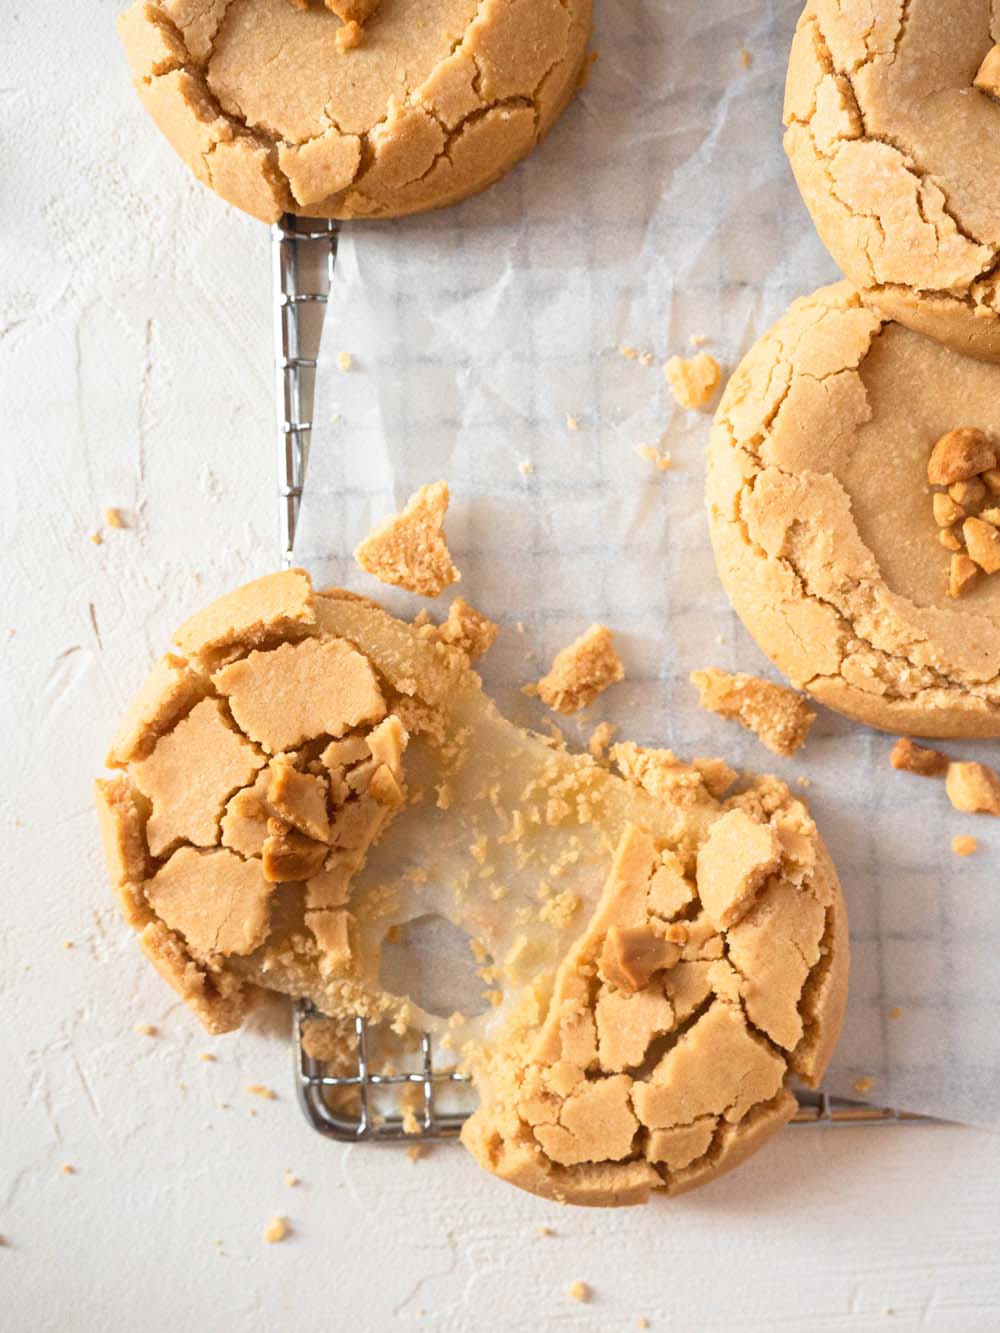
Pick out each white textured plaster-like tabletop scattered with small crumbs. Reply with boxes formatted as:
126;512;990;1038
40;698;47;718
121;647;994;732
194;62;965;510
0;0;1000;1333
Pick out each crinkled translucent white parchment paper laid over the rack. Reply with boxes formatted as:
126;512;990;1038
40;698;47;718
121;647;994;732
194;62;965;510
297;0;1000;1125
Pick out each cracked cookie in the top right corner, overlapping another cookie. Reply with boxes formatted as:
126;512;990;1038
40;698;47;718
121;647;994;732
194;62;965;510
784;0;1000;361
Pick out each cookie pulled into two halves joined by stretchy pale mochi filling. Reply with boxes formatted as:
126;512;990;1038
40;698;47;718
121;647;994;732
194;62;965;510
97;571;848;1204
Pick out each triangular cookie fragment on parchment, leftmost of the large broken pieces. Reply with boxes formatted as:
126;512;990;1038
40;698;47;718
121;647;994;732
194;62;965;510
355;481;461;597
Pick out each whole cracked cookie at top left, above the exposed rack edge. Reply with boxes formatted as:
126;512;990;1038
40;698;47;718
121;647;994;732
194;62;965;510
119;0;591;223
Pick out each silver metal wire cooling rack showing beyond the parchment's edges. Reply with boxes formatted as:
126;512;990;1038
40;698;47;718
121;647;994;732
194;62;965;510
272;213;927;1144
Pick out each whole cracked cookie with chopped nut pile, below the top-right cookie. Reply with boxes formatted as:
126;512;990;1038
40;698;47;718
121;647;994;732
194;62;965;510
708;283;1000;737
